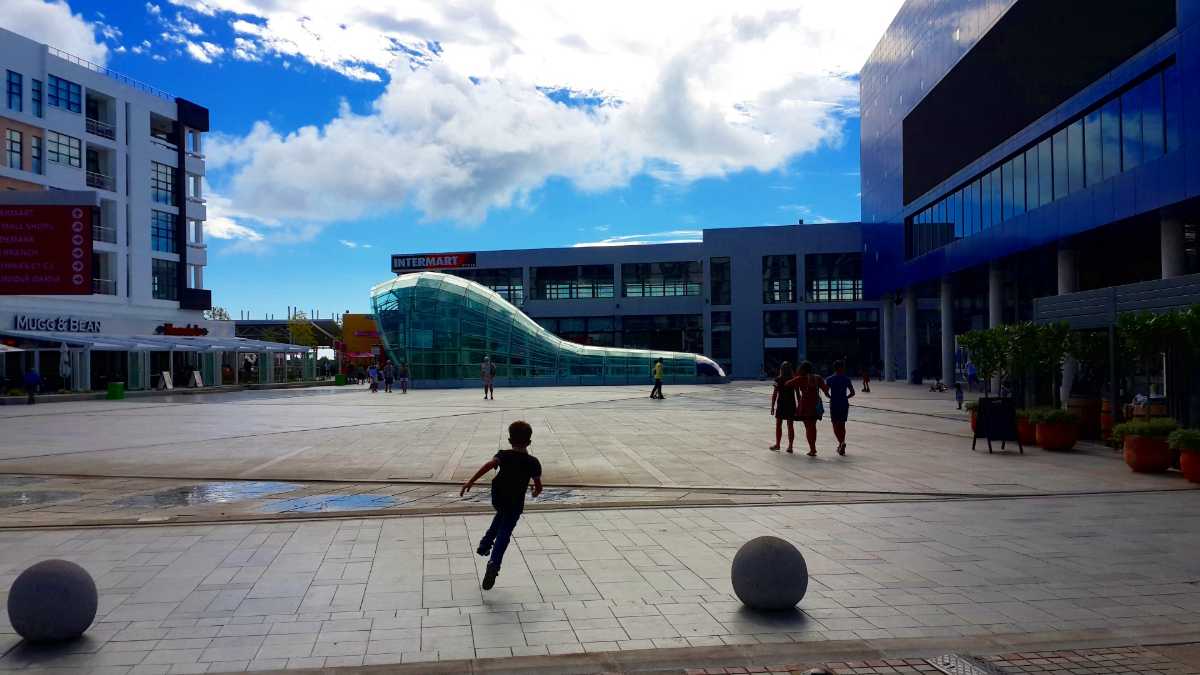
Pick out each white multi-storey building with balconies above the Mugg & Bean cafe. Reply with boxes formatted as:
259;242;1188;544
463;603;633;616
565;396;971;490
0;29;233;388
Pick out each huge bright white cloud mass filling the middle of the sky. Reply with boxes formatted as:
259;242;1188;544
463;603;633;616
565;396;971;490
196;0;899;236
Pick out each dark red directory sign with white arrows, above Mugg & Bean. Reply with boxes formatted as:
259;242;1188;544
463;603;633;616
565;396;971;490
0;205;94;295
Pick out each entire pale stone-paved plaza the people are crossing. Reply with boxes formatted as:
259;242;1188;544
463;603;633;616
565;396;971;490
0;383;1200;674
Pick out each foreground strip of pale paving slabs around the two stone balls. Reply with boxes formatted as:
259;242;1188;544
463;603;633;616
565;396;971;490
0;491;1200;673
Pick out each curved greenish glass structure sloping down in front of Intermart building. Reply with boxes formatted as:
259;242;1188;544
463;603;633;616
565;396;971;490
371;271;725;386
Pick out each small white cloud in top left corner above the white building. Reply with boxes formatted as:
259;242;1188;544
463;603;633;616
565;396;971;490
0;0;109;65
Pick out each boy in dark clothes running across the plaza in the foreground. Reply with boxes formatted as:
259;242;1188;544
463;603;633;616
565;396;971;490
458;419;541;591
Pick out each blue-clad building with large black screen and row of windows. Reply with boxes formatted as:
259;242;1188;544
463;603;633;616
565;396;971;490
860;0;1200;381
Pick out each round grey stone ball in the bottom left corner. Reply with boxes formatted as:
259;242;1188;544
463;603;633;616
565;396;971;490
8;560;98;643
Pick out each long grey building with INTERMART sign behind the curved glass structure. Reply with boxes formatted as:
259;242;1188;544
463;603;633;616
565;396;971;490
391;223;882;377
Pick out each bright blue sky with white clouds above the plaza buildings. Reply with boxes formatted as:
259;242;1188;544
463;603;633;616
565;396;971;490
0;0;901;318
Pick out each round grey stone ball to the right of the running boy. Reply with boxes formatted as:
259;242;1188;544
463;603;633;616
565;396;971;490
732;537;809;610
